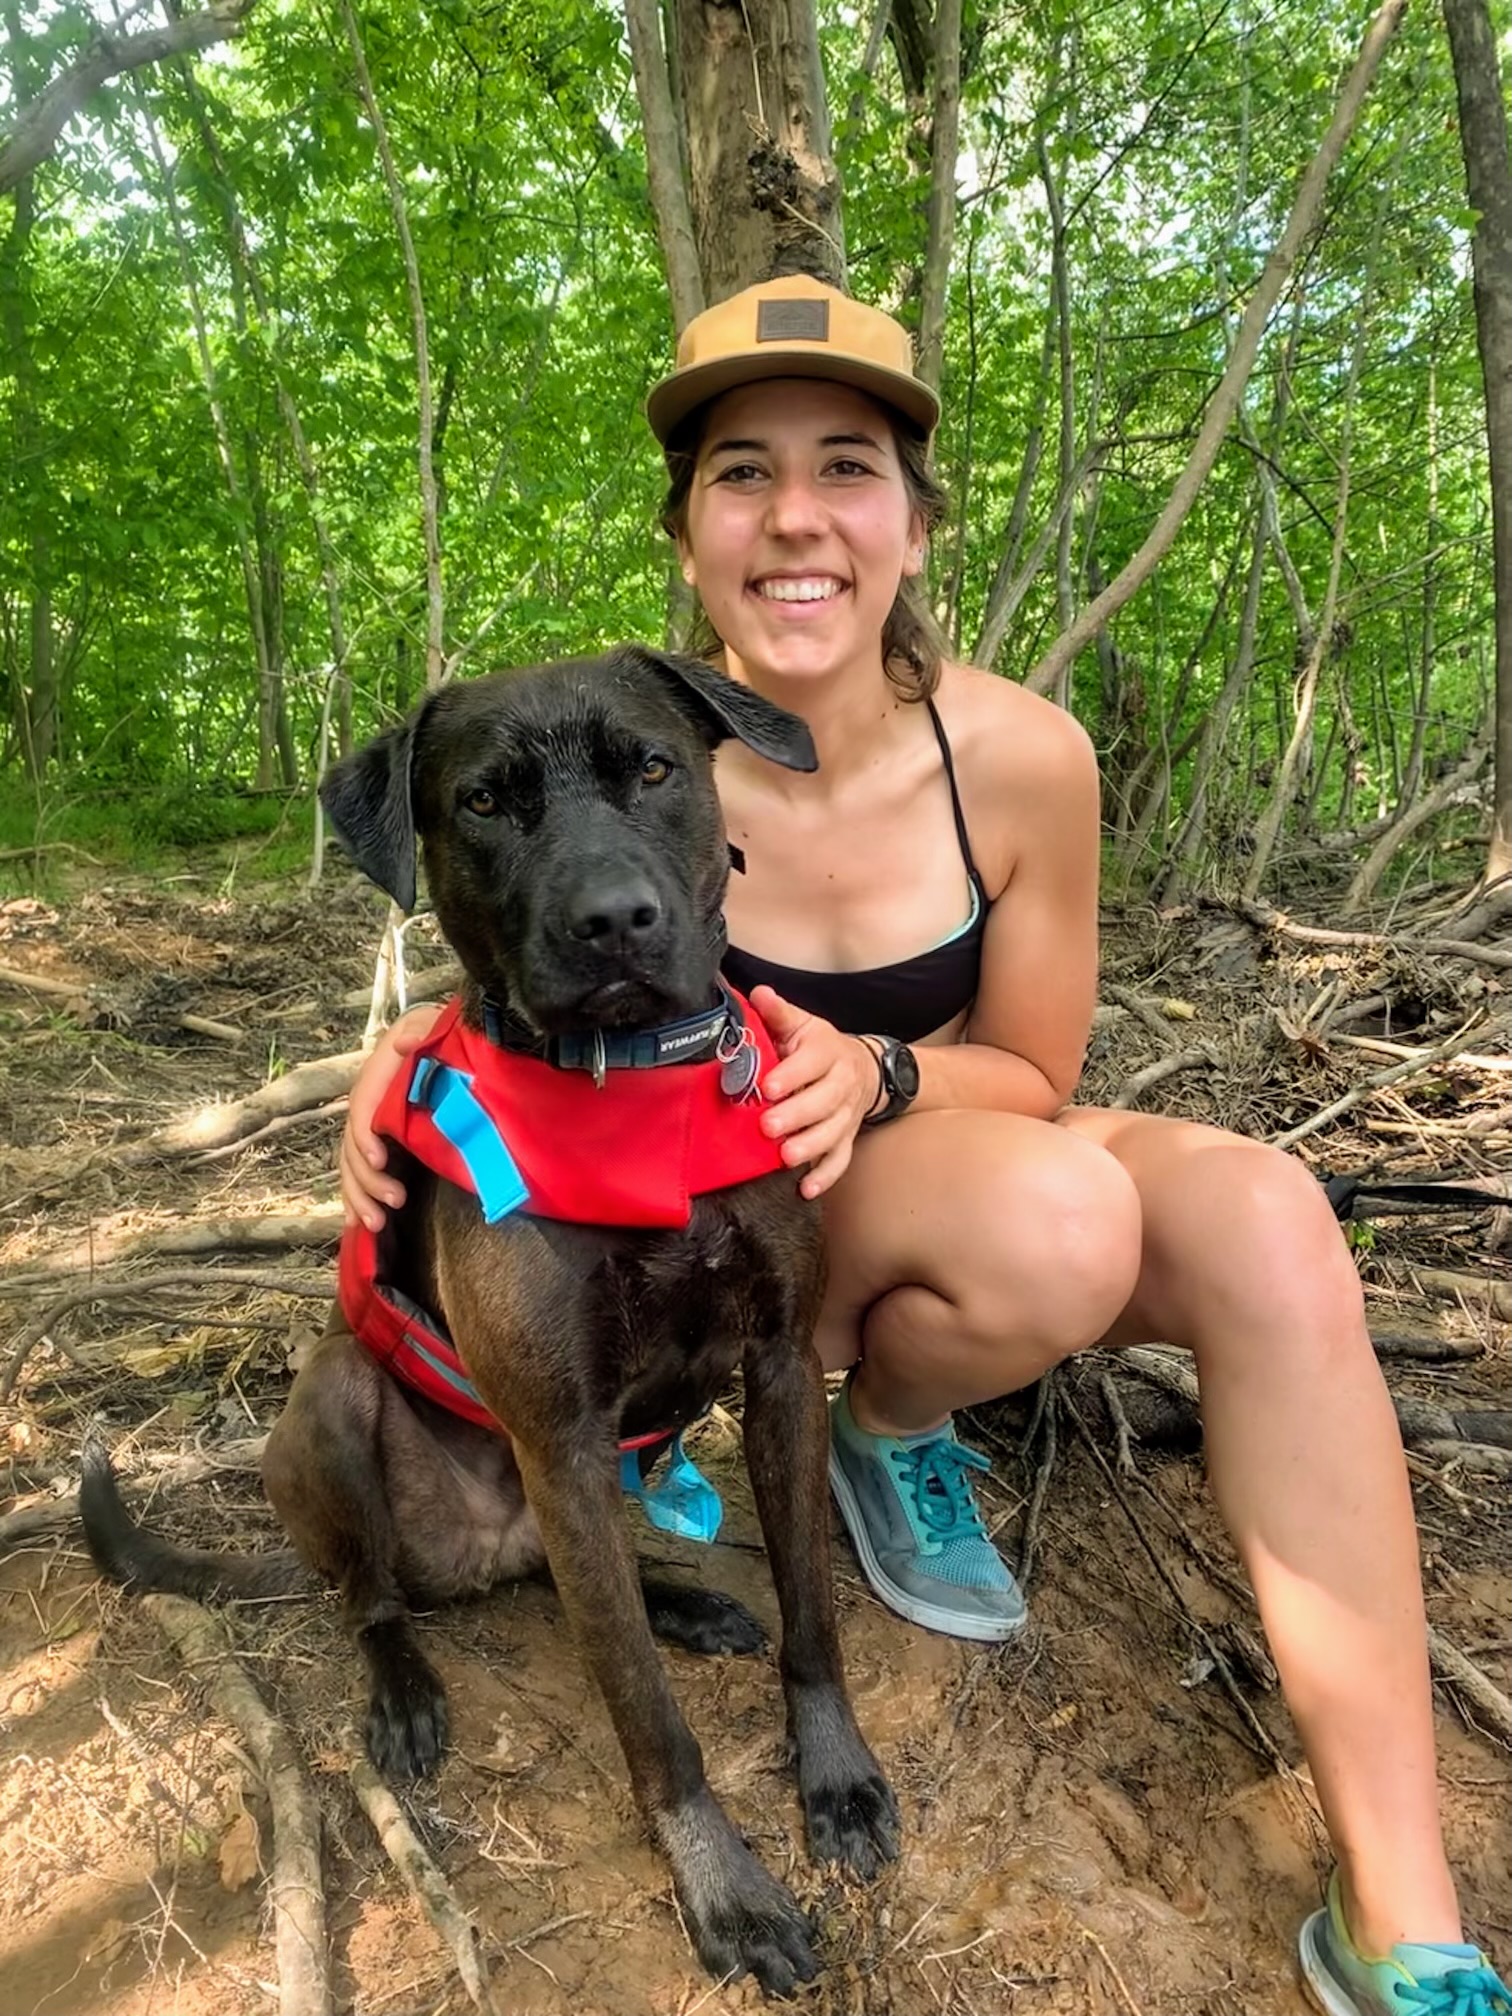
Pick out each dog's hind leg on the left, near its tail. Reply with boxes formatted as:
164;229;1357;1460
262;1314;448;1778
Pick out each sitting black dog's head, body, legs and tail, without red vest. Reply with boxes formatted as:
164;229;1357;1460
83;647;897;1994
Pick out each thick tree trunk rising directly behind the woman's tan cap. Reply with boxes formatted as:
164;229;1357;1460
677;0;845;302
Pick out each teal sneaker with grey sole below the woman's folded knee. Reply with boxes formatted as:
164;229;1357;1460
829;1379;1028;1643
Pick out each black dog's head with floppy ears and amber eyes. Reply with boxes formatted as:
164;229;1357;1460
321;645;816;1034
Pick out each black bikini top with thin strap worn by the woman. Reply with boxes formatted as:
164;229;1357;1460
724;700;992;1042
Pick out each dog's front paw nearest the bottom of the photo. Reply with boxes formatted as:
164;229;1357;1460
657;1786;818;1996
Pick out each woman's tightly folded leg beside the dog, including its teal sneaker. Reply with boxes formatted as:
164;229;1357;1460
818;1113;1139;1641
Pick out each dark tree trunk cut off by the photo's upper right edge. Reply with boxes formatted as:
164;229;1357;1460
1443;0;1512;881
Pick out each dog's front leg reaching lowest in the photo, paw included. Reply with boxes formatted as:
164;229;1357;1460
514;1423;818;1996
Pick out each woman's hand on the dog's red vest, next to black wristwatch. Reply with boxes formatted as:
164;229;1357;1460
750;988;881;1198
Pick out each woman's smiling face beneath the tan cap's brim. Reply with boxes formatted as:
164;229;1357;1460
677;379;923;679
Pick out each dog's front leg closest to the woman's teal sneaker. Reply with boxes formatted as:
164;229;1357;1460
746;1327;899;1879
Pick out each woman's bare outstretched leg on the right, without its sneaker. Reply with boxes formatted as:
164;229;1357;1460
1060;1109;1460;1954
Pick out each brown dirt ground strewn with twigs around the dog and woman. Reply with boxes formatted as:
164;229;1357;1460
0;867;1512;2016
